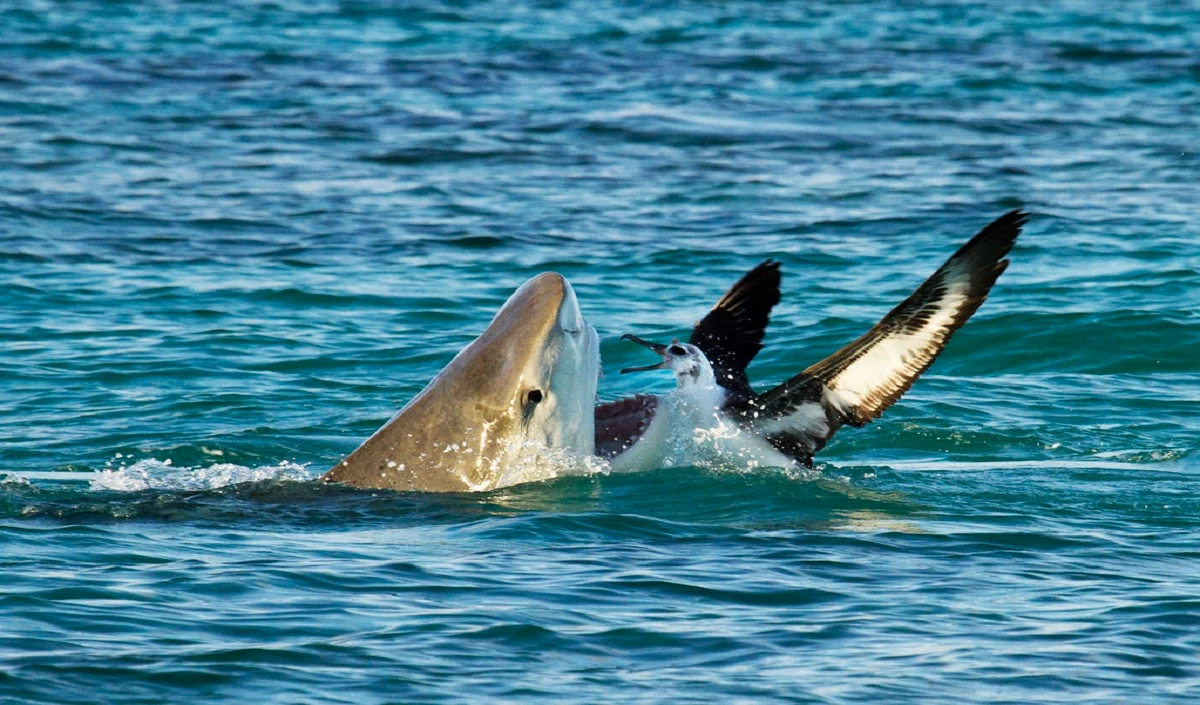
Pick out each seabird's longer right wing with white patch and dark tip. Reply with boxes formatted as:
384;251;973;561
745;210;1028;463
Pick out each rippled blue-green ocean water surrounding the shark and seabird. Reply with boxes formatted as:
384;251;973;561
0;0;1200;704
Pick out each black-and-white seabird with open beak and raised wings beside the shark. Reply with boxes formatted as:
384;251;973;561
595;210;1028;470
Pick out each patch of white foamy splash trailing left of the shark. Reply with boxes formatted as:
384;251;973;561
89;458;317;492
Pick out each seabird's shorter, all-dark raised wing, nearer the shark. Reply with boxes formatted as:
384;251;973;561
689;259;780;398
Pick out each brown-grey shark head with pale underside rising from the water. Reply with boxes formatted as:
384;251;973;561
325;272;600;492
